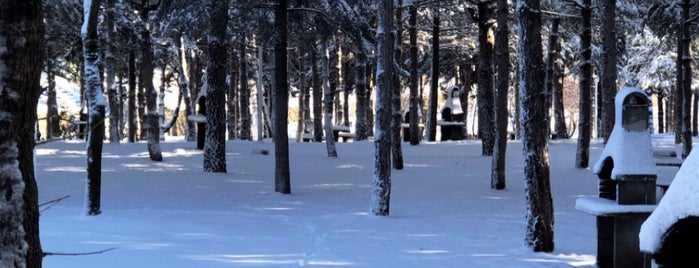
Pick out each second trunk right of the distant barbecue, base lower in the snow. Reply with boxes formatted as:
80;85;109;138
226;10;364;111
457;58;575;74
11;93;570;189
490;0;510;190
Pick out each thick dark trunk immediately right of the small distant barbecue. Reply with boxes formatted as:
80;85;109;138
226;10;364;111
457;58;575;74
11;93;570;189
476;0;495;156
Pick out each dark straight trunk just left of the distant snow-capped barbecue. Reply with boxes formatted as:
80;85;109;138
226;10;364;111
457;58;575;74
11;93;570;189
425;10;440;141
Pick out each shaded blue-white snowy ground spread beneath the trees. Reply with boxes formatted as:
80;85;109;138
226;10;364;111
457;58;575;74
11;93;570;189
36;135;677;268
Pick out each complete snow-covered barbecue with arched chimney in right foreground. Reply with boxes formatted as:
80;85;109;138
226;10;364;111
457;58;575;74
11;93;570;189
575;87;657;267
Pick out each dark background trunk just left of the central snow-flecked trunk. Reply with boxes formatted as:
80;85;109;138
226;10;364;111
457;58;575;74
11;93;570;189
354;51;369;141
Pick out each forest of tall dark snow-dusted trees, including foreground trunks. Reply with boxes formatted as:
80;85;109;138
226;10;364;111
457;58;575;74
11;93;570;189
0;0;699;267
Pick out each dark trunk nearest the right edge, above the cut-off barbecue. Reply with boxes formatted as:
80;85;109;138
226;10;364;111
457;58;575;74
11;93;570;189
678;0;692;159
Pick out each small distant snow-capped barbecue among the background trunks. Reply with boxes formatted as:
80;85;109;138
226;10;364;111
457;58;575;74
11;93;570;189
437;86;465;141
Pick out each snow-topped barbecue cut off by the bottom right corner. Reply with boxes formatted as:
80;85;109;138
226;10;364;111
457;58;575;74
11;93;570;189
639;149;699;267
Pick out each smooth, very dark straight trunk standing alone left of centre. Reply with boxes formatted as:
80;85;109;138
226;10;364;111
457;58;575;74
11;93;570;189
272;0;291;194
